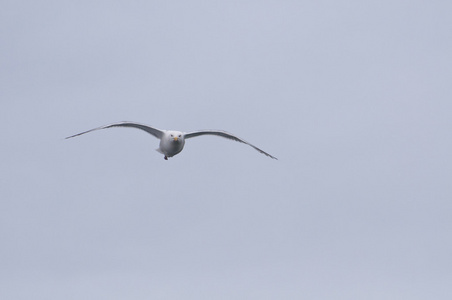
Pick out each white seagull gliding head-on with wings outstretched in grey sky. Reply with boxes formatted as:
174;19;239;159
66;121;277;160
